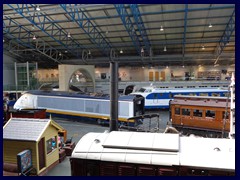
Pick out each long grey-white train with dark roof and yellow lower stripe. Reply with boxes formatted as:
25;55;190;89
13;90;144;125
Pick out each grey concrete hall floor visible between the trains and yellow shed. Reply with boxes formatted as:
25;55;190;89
45;110;169;176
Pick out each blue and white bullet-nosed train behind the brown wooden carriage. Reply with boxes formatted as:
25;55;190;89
131;86;229;109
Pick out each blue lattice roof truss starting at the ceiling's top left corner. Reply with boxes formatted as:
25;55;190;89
7;4;86;58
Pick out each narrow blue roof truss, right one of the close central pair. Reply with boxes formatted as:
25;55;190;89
130;4;151;55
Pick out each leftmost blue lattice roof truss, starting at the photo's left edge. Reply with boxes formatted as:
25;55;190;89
3;17;63;63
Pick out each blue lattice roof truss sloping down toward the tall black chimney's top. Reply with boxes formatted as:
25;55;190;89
60;4;112;57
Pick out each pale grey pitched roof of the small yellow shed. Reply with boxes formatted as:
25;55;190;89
3;118;61;141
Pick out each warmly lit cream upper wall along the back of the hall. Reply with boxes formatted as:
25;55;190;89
38;66;235;82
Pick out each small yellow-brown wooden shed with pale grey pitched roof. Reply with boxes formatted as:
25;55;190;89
3;118;63;175
